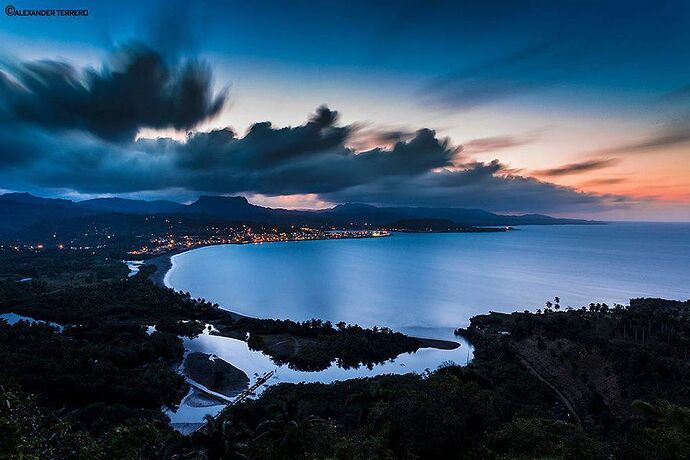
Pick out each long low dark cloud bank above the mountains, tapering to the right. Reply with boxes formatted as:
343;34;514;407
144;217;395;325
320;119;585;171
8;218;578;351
0;99;611;212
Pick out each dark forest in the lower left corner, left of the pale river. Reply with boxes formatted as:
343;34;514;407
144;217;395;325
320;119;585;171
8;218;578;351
0;321;187;459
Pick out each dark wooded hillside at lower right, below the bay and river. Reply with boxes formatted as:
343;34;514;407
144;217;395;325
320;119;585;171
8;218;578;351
185;299;690;459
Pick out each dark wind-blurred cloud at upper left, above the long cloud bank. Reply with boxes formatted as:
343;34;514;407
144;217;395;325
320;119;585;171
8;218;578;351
0;45;226;141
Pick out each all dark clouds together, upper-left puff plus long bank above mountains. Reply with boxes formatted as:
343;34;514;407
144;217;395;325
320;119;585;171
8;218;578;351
0;44;625;213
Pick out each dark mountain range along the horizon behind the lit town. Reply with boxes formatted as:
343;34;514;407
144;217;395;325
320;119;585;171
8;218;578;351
0;193;595;236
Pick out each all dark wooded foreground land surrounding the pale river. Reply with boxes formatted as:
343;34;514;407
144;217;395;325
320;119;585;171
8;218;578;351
0;250;690;459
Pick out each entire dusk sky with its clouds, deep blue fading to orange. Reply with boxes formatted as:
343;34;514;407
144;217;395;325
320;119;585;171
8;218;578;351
0;0;690;221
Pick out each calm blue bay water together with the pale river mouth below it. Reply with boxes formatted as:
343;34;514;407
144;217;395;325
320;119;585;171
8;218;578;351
165;223;690;423
